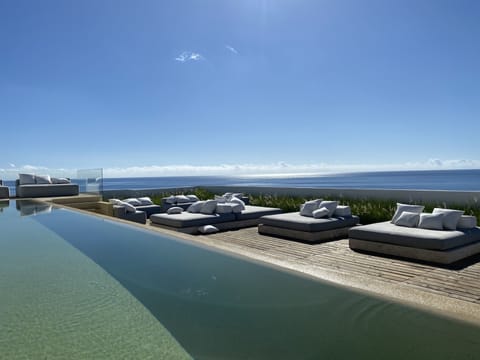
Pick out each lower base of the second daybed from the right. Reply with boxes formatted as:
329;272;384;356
258;224;350;243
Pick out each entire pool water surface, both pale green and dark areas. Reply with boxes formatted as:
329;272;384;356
0;201;480;359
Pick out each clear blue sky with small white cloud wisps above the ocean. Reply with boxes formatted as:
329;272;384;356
0;0;480;178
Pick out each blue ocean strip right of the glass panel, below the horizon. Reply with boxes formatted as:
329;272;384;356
98;169;480;191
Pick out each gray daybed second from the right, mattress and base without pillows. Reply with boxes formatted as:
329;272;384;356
258;212;359;242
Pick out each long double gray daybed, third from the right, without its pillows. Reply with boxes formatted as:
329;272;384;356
150;205;282;234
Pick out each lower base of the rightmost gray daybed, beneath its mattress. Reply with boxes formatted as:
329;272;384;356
349;238;480;265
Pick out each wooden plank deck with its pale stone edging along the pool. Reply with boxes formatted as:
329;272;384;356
42;199;480;325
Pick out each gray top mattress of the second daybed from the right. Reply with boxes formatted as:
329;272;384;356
260;212;359;232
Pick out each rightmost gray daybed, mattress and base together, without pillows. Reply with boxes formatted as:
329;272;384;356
348;221;480;264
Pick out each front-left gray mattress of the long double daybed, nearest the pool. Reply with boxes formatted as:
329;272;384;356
150;211;235;228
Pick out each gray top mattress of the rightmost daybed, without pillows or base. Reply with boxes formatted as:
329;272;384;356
348;221;480;250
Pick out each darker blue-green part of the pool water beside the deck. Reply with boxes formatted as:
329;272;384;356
0;204;480;359
